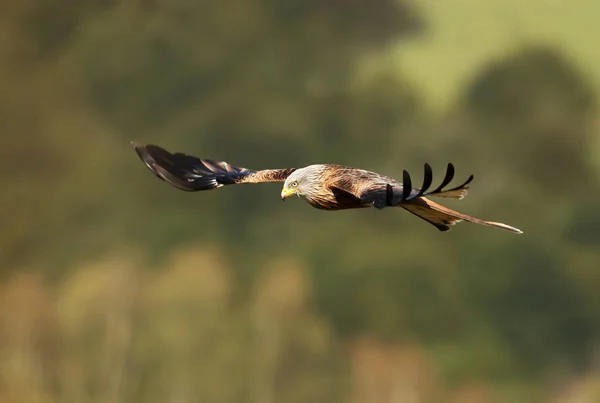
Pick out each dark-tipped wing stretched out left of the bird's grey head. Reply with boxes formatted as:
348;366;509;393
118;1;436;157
131;142;295;192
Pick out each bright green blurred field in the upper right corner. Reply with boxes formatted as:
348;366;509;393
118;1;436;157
396;0;600;107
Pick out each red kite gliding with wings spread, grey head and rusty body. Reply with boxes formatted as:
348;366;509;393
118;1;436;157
131;142;522;234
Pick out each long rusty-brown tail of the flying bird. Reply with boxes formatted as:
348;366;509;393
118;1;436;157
400;197;523;234
